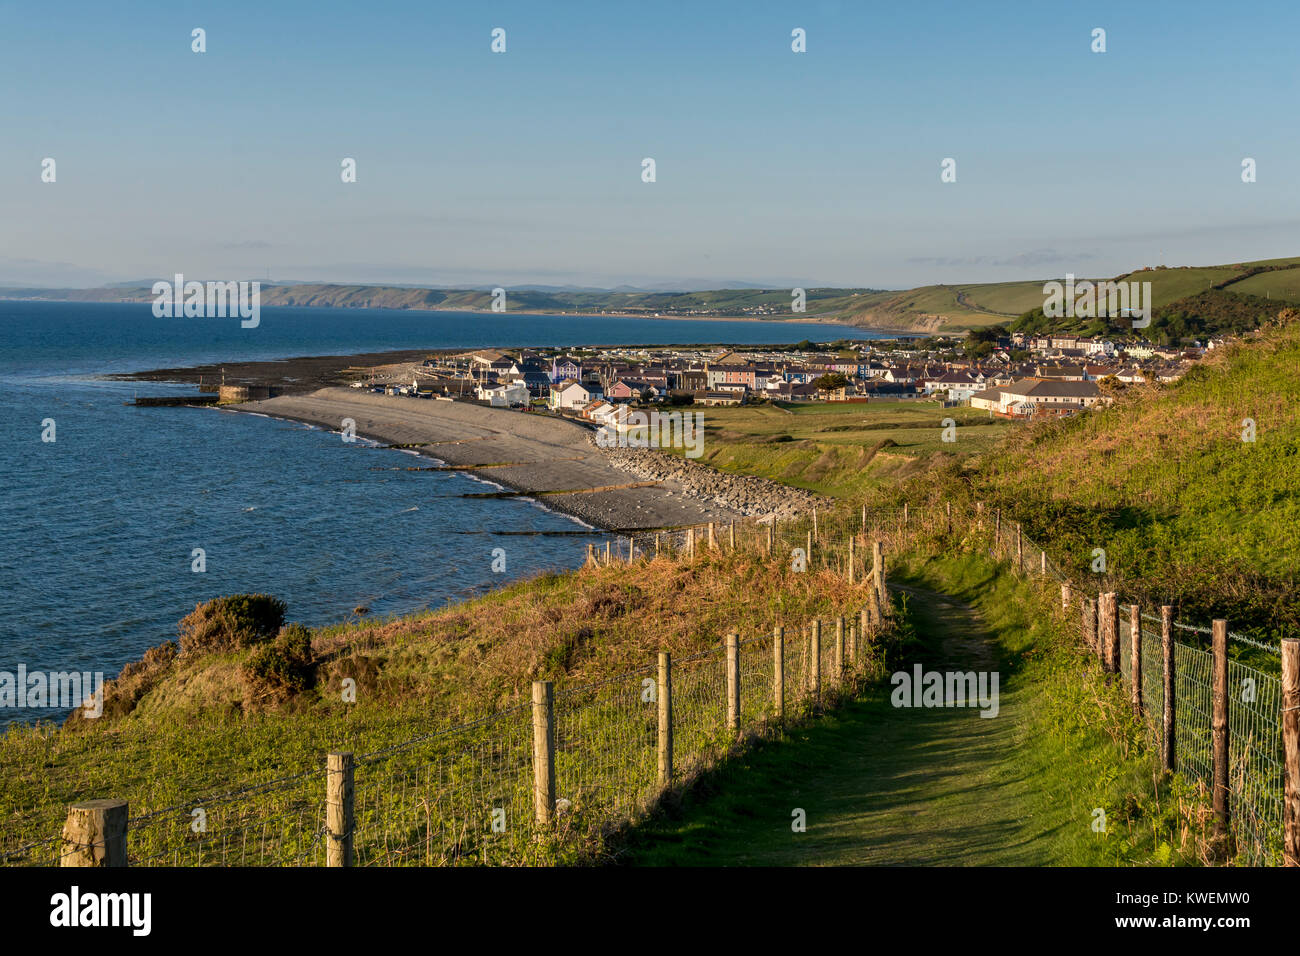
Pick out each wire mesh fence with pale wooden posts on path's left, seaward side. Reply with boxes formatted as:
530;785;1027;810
10;518;888;866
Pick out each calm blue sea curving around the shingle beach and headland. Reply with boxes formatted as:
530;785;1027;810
0;302;875;726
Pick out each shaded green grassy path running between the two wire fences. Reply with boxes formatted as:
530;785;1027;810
628;574;1062;866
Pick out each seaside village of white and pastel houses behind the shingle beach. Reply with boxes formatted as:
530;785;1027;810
354;334;1222;424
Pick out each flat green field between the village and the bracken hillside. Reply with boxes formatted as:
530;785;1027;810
665;402;1015;498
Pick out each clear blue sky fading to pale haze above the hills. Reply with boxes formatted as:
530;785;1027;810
0;0;1300;289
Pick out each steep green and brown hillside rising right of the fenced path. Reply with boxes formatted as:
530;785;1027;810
945;310;1300;636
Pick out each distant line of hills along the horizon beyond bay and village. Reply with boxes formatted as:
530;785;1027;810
0;258;1300;339
